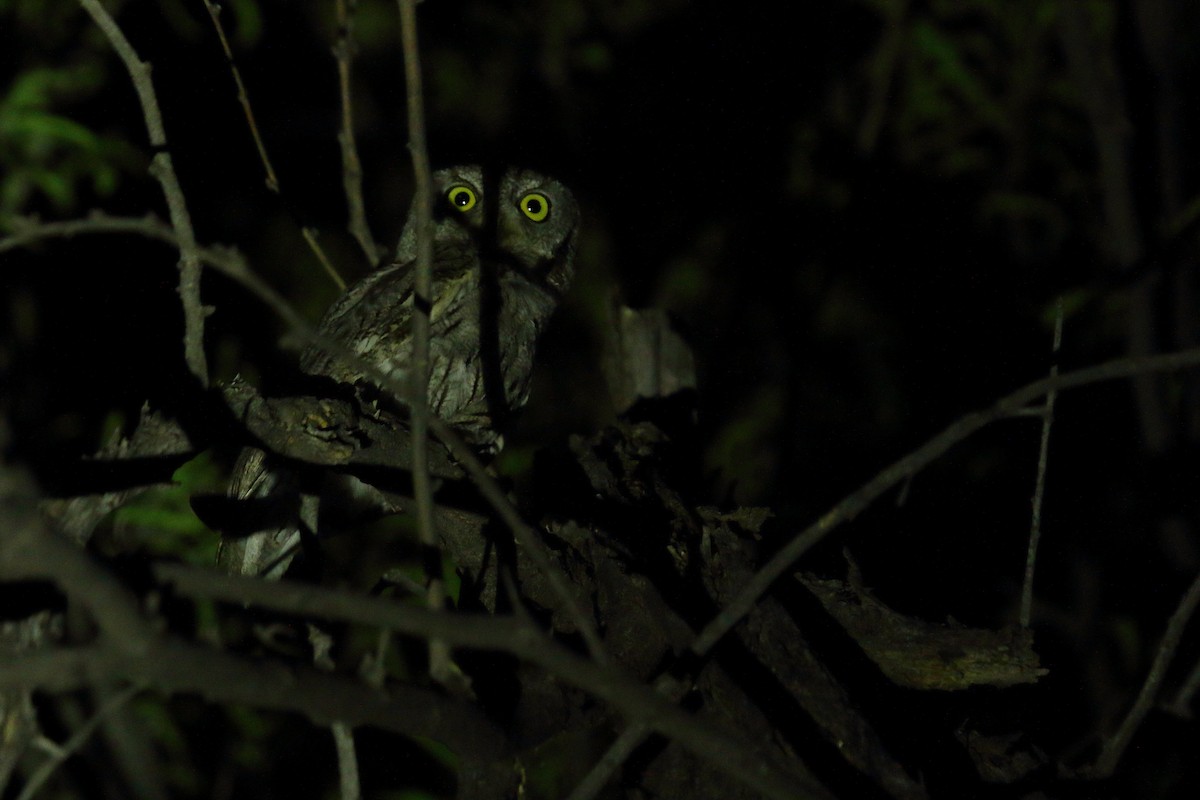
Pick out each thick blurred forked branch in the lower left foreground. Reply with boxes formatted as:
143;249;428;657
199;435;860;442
0;455;506;760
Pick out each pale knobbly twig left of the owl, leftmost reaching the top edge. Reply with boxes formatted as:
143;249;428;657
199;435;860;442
79;0;209;387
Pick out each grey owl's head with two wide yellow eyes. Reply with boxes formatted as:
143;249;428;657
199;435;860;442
398;166;580;293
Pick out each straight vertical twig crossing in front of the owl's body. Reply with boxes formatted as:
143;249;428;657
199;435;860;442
397;0;456;682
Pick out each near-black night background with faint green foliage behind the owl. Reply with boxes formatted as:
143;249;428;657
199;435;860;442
7;0;1200;796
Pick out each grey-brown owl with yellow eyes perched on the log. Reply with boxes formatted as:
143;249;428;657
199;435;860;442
225;167;580;577
